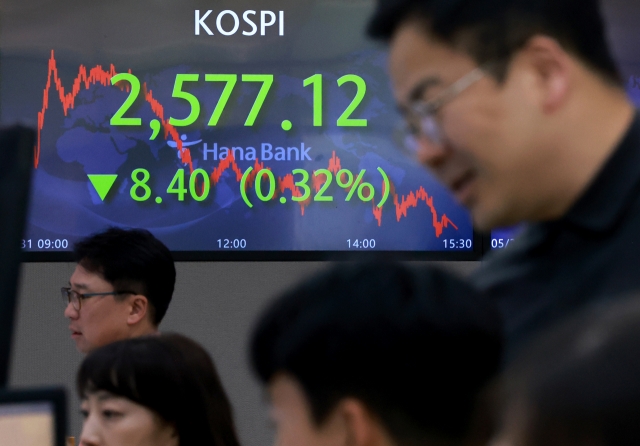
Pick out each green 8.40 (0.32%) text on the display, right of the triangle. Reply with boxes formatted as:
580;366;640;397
129;167;391;208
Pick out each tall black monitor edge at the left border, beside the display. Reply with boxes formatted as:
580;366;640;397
0;126;35;386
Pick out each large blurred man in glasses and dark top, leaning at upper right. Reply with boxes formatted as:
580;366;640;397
369;0;640;354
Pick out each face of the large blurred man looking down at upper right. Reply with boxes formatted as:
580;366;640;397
389;21;549;230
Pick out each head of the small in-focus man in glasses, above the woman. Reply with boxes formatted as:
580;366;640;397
62;228;176;353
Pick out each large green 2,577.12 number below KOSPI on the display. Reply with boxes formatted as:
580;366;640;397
110;73;367;130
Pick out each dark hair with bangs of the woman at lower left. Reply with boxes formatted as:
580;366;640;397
76;334;239;446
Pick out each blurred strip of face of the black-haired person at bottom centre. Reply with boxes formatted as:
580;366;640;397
269;374;343;446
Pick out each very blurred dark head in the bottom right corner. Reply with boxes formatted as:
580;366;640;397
491;297;640;446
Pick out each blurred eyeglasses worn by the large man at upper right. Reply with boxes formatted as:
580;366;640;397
401;67;485;155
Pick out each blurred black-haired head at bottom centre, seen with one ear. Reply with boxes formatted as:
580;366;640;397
251;264;501;446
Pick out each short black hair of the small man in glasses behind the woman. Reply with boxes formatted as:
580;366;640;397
73;228;176;326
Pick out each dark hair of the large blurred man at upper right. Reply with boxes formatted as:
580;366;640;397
367;0;621;85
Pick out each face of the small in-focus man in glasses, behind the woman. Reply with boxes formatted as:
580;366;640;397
64;265;130;353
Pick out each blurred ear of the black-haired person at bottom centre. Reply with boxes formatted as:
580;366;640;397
336;398;393;446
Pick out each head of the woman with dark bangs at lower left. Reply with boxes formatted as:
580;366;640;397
76;334;239;446
